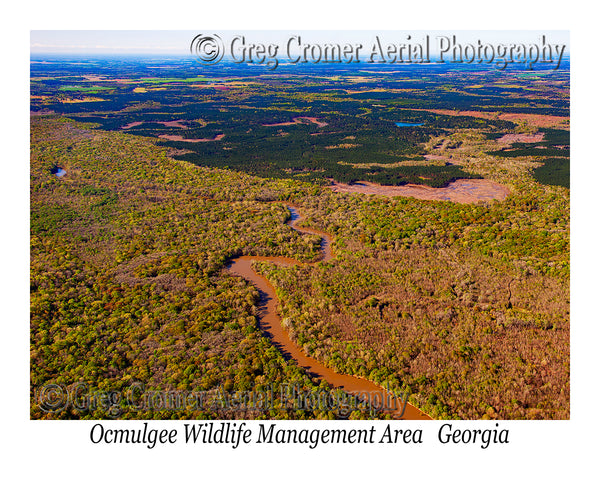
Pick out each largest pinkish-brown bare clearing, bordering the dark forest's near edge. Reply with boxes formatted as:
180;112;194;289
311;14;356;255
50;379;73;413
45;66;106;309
330;179;510;203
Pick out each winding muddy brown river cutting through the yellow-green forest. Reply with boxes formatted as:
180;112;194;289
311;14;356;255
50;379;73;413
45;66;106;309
227;205;431;420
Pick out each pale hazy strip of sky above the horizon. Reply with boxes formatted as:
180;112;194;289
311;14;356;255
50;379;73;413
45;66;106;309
30;30;570;55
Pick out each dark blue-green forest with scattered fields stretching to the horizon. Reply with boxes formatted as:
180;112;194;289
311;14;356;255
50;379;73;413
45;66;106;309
31;59;569;187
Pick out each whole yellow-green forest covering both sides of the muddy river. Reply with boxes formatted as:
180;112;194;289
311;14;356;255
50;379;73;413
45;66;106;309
31;116;569;418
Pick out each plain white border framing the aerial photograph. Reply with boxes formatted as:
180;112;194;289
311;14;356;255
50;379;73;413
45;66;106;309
1;0;600;478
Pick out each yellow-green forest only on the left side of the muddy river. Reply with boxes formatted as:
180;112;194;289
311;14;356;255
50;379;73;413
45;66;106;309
31;118;360;418
